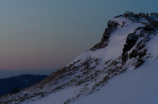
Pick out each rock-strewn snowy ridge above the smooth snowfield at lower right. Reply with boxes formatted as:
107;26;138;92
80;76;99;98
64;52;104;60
0;15;158;104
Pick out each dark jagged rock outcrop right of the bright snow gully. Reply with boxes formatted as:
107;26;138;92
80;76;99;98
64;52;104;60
122;25;155;68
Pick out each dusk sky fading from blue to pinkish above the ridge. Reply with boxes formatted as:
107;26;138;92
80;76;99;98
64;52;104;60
0;0;158;78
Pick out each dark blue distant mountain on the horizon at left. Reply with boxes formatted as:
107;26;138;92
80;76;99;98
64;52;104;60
0;74;48;96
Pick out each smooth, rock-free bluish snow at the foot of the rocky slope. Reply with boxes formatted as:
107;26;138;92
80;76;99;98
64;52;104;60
25;60;158;104
